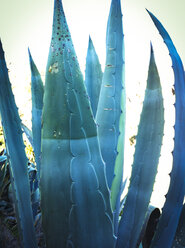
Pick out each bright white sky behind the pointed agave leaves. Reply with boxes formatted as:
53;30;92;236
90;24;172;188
0;0;185;207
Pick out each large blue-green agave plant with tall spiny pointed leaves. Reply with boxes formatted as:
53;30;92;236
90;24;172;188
0;0;185;248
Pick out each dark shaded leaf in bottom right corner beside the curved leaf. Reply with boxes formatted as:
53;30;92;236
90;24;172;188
172;204;185;248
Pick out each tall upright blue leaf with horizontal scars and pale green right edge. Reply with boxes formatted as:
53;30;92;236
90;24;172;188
96;0;125;223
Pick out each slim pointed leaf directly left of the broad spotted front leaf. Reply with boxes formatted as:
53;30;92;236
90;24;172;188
28;49;44;180
